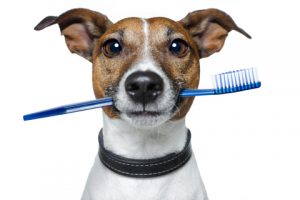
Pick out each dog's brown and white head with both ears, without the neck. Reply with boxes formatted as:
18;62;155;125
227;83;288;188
35;9;250;127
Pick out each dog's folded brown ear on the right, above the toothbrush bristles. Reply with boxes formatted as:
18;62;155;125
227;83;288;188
179;9;251;58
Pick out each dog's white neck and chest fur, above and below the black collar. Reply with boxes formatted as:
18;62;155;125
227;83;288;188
82;114;207;200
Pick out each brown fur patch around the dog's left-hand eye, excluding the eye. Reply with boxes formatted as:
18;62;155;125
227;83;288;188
93;18;144;118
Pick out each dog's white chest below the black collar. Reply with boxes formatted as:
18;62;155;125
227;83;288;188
82;156;207;200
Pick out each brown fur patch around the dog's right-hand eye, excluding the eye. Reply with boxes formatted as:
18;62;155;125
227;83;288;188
148;18;200;119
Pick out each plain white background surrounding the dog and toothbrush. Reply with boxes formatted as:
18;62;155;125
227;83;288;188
0;0;300;200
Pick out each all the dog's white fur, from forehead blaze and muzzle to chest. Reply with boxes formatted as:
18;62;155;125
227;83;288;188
82;20;207;200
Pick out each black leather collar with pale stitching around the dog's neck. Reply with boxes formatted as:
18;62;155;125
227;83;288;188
98;130;192;178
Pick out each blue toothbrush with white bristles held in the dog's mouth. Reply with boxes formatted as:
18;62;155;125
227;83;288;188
23;68;261;121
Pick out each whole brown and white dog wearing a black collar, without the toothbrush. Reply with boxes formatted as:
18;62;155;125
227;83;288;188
35;8;251;200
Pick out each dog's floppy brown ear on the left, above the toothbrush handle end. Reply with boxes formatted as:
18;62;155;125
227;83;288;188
34;8;112;61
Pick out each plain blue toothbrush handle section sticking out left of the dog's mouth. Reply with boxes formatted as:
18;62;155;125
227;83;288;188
23;97;112;121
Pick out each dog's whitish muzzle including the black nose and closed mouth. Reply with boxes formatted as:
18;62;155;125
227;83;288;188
114;70;177;128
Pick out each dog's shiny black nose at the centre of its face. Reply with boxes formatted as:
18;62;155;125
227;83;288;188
125;71;164;104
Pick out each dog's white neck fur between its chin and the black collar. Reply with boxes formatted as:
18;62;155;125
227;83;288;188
103;114;186;159
